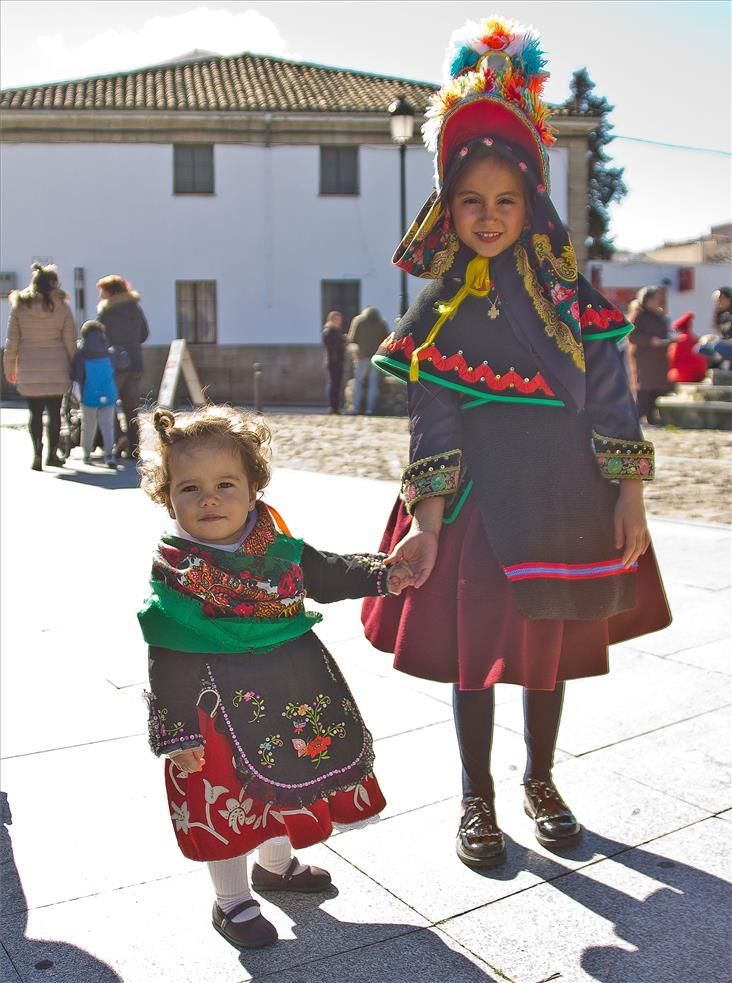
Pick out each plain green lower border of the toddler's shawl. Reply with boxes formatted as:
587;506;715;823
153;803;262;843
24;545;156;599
137;580;322;654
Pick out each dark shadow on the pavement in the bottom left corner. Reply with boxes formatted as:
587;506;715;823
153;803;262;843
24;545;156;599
0;792;122;983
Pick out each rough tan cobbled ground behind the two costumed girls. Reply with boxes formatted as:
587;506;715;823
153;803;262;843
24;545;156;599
268;412;732;522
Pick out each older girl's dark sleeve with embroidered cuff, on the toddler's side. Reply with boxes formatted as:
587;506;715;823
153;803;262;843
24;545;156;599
401;379;462;512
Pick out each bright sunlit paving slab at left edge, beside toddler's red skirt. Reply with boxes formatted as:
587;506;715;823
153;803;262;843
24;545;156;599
2;737;179;908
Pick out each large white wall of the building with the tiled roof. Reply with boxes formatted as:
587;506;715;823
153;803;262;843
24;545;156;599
0;136;568;344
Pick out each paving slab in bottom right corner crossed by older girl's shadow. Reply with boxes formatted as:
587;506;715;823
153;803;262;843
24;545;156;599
442;819;732;983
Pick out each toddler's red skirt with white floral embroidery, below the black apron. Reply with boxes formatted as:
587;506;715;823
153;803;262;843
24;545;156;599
165;709;386;860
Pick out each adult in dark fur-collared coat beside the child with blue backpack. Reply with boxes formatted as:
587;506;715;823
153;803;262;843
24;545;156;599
97;274;150;457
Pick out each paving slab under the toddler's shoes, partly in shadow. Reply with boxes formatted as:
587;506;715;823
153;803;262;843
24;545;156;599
3;846;428;983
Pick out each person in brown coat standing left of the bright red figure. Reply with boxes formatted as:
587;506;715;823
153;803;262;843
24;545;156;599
628;287;672;423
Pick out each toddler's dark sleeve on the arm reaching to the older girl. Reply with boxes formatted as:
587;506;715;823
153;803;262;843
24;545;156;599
300;543;387;604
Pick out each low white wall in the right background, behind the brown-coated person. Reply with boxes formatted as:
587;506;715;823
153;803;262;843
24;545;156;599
587;260;732;335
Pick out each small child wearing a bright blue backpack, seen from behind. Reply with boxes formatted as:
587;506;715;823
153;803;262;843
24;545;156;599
71;321;126;468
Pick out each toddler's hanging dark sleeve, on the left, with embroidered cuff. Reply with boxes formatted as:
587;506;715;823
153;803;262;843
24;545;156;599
145;646;204;755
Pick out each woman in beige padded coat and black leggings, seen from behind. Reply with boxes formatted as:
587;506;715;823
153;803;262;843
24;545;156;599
3;263;76;471
